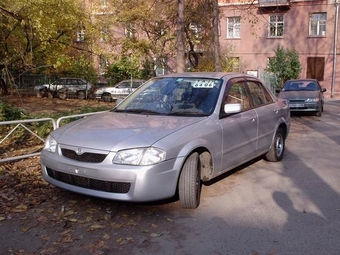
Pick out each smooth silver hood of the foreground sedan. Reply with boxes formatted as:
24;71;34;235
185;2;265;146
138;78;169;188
52;112;206;151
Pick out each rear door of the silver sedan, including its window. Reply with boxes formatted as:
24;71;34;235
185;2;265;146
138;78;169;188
247;80;279;153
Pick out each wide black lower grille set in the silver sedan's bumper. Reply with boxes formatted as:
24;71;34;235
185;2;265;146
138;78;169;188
46;167;131;193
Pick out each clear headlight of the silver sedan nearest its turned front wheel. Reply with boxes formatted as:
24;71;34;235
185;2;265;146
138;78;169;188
112;147;165;166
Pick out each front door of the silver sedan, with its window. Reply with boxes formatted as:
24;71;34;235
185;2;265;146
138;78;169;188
220;79;258;169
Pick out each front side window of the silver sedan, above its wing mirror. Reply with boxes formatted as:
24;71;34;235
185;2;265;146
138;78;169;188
224;82;251;111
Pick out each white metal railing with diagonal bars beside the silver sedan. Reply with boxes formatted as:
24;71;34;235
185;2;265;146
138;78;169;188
0;111;106;163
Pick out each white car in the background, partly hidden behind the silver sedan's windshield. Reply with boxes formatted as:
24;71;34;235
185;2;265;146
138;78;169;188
94;79;145;102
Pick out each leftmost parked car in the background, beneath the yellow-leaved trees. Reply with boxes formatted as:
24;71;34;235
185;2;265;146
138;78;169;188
34;78;93;99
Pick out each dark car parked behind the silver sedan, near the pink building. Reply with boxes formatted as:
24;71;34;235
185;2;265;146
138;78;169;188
278;79;326;117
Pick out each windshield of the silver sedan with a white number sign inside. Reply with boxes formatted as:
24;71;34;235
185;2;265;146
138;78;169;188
113;77;222;116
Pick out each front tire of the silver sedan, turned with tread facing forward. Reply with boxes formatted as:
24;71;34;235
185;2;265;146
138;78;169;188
178;152;202;209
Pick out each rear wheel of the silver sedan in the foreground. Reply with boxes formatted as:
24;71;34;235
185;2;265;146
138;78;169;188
265;128;285;162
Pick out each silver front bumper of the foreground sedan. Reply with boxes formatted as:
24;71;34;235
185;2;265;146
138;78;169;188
41;150;184;202
